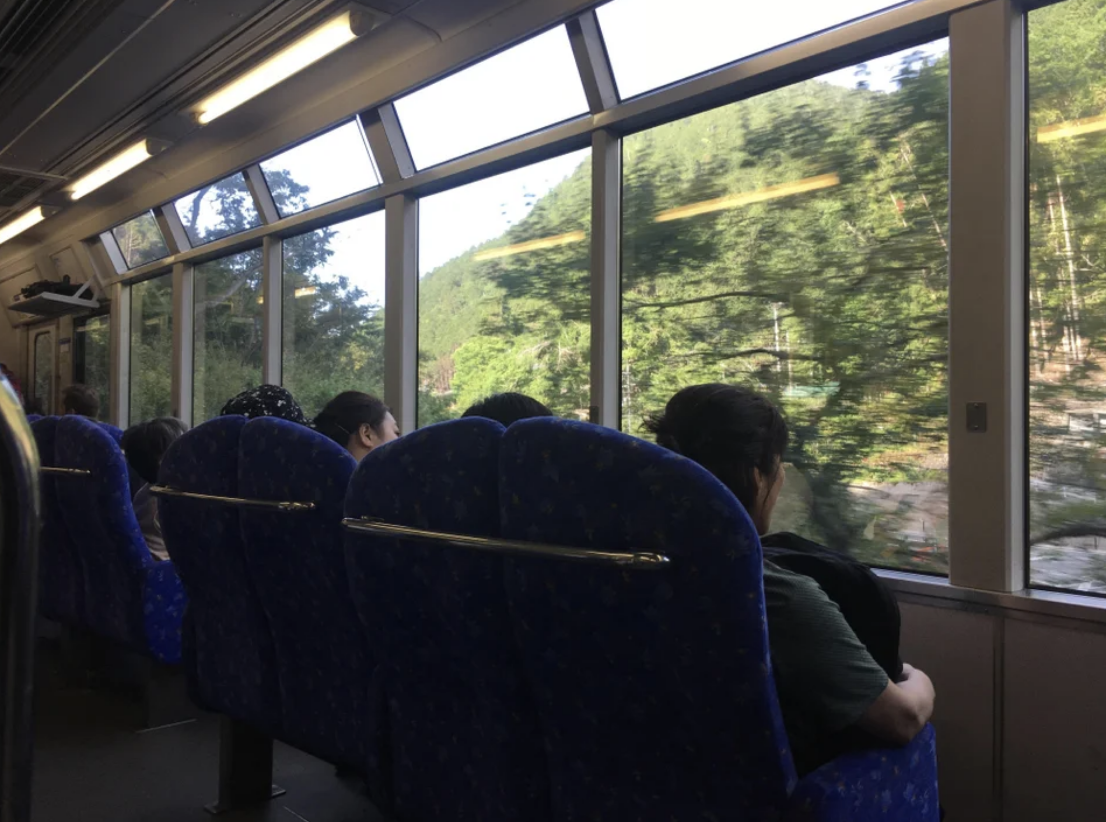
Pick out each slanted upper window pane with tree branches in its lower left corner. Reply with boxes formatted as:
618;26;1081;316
261;121;380;217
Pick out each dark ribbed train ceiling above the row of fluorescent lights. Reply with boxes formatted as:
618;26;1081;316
0;0;488;223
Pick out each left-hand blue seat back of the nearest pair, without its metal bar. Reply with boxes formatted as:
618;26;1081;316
346;418;549;822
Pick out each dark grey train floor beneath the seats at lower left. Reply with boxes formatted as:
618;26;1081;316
31;644;383;822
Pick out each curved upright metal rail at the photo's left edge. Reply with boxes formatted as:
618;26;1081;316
0;376;41;822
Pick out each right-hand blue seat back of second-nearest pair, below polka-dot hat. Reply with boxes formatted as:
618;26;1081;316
238;417;379;772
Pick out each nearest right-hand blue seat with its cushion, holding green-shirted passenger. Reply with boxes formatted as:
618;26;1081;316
500;419;937;822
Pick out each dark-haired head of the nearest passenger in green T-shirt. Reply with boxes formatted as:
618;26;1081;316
646;383;787;533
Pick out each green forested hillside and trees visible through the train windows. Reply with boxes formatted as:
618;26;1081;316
125;0;1106;583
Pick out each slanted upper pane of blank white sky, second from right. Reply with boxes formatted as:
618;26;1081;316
395;27;587;168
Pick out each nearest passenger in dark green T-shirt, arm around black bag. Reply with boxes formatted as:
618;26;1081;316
647;384;935;774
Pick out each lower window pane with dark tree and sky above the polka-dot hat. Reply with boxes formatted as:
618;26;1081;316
282;211;384;416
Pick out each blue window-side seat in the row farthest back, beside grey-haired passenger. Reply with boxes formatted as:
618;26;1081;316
54;416;186;664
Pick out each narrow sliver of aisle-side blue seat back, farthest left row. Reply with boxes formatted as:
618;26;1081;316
28;417;84;625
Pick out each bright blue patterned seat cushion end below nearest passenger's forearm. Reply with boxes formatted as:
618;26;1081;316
783;725;940;822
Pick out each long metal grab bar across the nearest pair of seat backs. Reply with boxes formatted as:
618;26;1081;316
342;519;671;571
